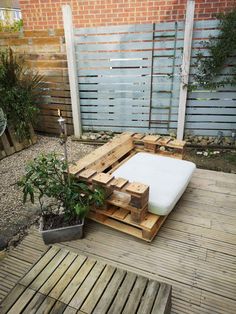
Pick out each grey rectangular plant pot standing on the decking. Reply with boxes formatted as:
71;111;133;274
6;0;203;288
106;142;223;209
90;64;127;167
39;217;84;244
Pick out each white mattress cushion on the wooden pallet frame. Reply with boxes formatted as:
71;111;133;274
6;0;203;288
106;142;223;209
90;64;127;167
113;153;196;215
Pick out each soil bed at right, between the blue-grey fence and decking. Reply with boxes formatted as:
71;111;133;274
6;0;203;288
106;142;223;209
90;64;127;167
184;148;236;173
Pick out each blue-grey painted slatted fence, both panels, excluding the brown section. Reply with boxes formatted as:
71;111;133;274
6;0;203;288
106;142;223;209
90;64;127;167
75;20;236;135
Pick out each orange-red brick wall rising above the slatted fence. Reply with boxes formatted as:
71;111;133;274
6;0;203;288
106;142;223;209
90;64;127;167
20;0;236;30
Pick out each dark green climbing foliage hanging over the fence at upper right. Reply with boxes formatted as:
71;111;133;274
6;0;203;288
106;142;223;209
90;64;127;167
190;9;236;89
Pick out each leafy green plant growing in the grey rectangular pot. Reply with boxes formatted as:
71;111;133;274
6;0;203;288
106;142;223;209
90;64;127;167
18;153;105;219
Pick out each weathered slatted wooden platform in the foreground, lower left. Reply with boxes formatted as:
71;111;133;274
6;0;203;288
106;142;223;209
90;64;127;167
0;247;171;314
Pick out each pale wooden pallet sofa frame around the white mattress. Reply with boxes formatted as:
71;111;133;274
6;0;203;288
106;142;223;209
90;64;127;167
69;133;185;242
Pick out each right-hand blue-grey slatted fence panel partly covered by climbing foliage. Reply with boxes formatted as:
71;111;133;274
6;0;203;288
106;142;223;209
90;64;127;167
185;20;236;136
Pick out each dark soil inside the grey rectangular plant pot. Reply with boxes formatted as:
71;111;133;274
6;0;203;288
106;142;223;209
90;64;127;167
43;214;81;230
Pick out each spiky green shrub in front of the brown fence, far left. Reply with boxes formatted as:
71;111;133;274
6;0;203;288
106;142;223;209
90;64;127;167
0;49;42;140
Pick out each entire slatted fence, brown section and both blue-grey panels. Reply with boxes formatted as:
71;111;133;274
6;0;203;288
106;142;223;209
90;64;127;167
0;20;236;135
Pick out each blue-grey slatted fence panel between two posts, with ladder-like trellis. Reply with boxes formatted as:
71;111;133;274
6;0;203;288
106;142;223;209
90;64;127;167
75;22;183;133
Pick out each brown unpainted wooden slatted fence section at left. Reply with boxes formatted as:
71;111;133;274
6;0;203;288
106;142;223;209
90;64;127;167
0;29;73;134
